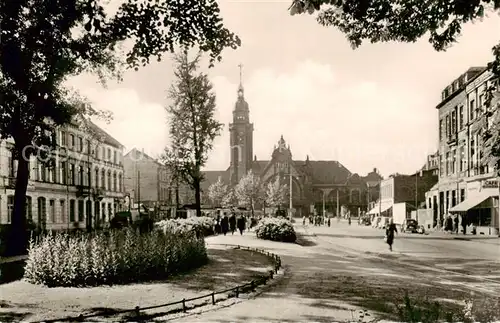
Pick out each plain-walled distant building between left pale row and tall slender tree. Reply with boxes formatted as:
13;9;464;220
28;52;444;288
123;148;192;210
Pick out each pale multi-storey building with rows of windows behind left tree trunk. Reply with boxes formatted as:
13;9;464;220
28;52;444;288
0;121;123;230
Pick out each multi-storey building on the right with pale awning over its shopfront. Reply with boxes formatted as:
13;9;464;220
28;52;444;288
427;67;499;234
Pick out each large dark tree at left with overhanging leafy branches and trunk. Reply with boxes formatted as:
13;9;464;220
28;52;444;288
0;0;240;253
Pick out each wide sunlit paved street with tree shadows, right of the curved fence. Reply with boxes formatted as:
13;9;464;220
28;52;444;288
172;222;500;322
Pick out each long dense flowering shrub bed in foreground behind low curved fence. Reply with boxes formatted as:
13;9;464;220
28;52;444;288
24;228;208;287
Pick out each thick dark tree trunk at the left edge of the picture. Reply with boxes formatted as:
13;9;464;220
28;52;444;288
6;148;29;256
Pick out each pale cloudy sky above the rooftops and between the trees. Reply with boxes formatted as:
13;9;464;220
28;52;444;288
69;0;500;176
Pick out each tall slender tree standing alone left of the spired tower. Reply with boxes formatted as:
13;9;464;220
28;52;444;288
164;52;223;216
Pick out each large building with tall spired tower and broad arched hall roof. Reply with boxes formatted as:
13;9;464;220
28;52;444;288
202;72;382;216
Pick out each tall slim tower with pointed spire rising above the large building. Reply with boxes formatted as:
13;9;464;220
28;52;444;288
229;64;253;185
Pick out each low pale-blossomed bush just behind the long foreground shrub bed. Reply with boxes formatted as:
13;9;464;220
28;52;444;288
156;216;215;237
